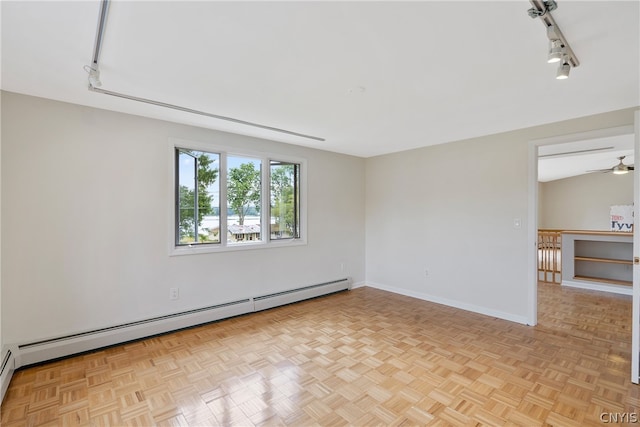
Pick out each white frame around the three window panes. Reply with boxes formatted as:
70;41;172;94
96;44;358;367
168;138;308;256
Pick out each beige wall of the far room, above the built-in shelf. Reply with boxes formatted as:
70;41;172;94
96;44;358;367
538;173;633;230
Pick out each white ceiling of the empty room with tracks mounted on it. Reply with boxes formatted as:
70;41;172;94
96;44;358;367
1;0;640;160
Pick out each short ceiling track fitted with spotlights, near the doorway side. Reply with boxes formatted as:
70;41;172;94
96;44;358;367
527;0;580;80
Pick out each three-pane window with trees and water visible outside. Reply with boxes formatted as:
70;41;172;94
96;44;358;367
172;147;304;253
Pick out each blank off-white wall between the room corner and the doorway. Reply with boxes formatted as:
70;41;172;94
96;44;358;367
366;110;633;323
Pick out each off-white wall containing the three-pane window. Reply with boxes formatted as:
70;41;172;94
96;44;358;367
2;92;365;343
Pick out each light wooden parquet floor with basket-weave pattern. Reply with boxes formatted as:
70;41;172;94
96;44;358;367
1;284;640;427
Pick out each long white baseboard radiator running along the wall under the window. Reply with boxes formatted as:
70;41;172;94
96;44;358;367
12;278;351;372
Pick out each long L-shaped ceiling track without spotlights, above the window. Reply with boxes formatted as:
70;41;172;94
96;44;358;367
84;0;325;141
